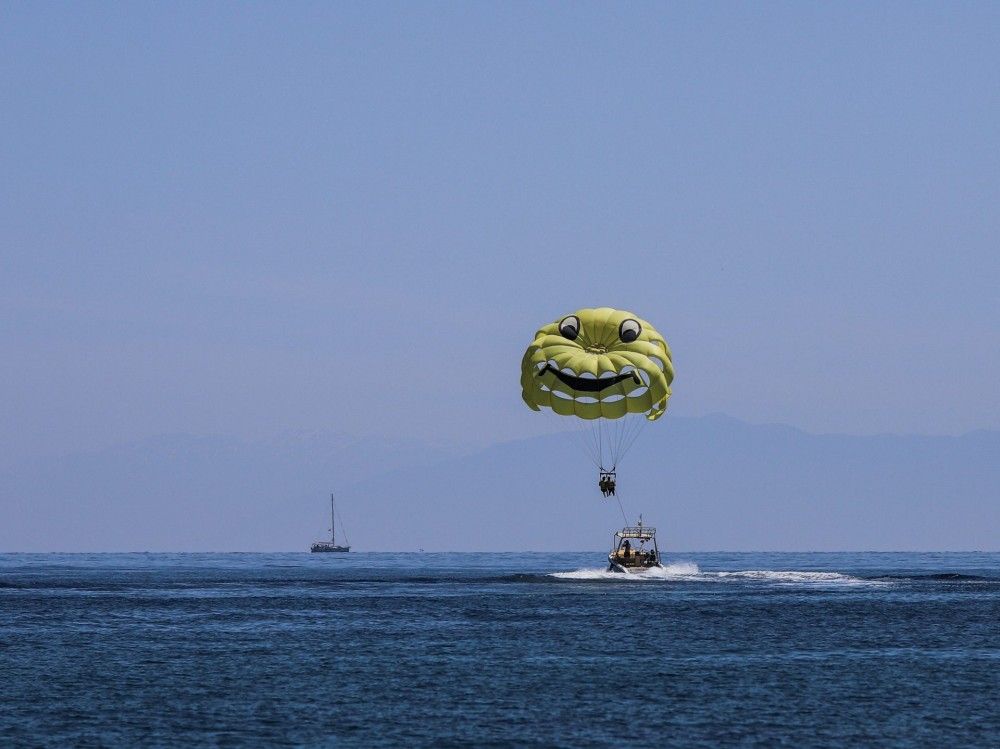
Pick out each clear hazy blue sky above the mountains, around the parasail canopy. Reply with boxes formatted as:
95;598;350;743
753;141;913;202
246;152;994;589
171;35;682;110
0;3;1000;457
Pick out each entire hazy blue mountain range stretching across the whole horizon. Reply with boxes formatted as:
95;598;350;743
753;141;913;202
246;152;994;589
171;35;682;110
0;415;1000;551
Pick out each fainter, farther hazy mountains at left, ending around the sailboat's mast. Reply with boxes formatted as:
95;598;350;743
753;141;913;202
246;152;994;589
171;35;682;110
0;433;455;552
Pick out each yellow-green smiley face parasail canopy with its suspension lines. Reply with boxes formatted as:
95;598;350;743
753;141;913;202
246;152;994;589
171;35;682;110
521;307;674;490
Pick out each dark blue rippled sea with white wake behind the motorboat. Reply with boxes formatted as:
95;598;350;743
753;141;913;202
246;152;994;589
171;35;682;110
0;553;1000;747
